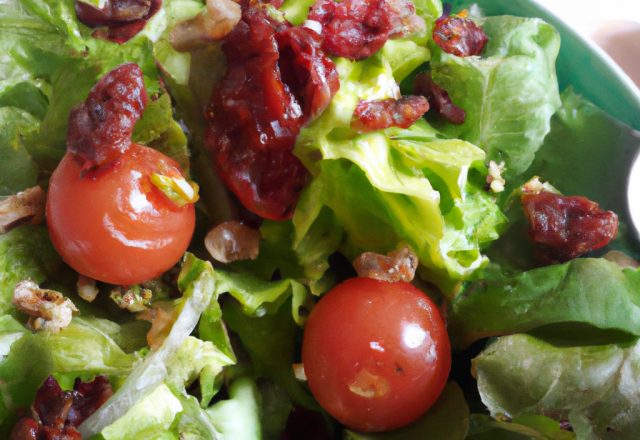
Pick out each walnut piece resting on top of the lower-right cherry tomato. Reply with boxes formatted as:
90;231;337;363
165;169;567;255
353;246;419;282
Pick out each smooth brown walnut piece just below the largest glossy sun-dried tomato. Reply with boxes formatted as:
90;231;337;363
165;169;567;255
204;220;262;263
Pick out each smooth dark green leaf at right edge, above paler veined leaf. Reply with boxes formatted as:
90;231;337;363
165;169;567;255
447;258;640;348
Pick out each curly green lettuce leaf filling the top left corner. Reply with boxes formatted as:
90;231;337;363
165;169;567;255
0;0;161;171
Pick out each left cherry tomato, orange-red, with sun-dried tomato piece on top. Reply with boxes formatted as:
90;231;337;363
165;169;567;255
47;144;195;285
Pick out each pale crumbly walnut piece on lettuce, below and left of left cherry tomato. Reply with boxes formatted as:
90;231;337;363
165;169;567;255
11;280;78;333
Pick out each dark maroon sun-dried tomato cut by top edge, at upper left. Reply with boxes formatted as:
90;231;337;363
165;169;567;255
76;0;162;44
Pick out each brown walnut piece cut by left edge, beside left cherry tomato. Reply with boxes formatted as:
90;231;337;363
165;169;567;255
0;186;46;234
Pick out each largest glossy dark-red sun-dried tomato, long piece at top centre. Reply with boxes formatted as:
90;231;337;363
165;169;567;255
206;0;339;220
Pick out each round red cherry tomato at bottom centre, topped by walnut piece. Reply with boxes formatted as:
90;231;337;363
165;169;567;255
302;278;451;432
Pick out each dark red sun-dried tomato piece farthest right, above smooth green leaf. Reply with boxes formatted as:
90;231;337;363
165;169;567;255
522;192;618;264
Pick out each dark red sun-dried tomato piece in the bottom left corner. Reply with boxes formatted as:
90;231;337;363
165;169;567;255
9;376;113;440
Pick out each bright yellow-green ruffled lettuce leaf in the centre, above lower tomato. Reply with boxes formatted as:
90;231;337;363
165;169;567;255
293;51;506;293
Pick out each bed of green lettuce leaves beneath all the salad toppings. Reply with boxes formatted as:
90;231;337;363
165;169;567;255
0;0;640;440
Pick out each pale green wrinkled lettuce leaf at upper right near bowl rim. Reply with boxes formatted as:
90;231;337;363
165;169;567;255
431;16;560;180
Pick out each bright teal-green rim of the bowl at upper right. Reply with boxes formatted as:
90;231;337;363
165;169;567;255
445;0;640;130
